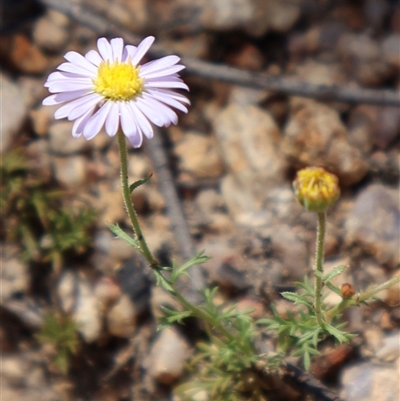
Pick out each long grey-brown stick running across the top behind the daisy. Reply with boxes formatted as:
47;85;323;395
40;0;400;106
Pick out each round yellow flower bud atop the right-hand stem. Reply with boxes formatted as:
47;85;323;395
293;167;340;213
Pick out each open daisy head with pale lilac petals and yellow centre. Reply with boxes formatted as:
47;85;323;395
43;36;190;148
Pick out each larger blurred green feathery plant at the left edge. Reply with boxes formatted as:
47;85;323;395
0;149;96;269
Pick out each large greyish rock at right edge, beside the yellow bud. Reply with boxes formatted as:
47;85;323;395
345;184;400;268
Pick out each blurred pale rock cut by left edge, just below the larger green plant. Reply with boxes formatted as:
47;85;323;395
0;244;30;302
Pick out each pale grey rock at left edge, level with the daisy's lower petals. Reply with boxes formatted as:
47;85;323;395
0;73;28;152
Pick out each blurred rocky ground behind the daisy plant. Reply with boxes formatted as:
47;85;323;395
0;0;400;401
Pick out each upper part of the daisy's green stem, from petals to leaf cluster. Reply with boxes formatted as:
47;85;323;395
118;131;160;269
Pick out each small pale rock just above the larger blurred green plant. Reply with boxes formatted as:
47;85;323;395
53;155;87;188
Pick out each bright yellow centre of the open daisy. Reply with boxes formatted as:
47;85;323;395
93;61;144;101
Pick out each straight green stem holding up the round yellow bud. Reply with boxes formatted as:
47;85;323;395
314;212;326;328
